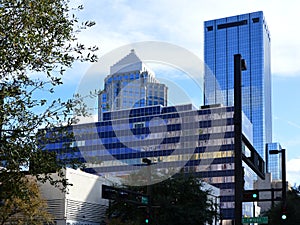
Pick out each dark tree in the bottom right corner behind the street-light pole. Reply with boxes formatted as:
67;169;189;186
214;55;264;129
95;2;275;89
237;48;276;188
265;186;300;225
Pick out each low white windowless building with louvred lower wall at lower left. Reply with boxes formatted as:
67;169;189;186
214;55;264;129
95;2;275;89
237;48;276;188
40;168;111;225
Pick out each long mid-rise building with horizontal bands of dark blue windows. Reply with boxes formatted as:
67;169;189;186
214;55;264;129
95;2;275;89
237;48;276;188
45;105;253;219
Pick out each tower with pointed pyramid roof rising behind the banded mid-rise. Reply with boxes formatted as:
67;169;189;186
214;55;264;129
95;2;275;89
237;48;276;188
98;49;168;121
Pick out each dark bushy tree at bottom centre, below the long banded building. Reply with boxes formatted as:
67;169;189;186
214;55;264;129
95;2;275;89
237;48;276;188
107;173;218;225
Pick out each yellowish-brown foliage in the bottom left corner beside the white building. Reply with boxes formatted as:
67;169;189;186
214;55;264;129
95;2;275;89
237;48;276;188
0;177;52;225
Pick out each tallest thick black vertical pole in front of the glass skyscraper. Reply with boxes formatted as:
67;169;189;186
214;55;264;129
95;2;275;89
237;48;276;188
234;54;243;225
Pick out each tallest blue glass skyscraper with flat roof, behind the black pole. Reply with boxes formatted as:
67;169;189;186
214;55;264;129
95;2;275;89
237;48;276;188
204;11;272;159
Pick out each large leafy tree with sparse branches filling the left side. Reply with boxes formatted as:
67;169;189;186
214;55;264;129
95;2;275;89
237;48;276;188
0;0;97;203
